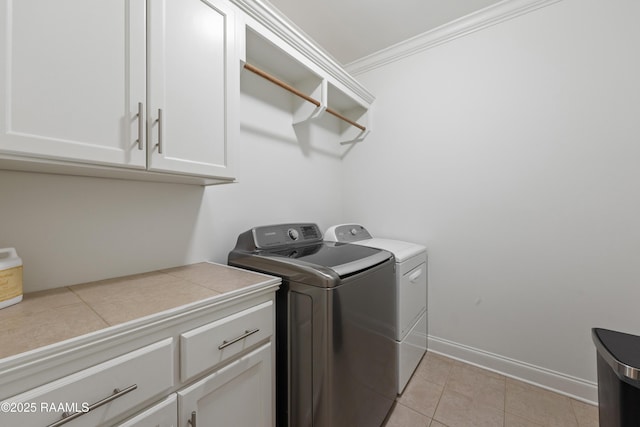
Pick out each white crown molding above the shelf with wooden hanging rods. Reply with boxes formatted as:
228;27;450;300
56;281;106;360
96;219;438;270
231;0;375;104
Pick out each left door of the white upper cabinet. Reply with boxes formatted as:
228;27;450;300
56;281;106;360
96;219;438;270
0;0;146;168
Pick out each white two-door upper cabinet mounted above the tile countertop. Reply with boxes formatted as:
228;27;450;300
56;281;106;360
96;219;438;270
0;0;240;181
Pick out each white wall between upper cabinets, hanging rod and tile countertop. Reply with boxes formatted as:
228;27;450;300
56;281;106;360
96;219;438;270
0;68;342;292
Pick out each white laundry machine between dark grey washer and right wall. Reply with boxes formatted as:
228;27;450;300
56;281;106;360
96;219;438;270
324;224;428;394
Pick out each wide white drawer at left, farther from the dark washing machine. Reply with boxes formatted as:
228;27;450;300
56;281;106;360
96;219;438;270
0;338;174;427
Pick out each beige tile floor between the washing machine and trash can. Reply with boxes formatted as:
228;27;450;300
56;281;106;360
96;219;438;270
384;353;598;427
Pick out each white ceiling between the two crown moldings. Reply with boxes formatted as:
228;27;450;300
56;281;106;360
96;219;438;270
269;0;502;65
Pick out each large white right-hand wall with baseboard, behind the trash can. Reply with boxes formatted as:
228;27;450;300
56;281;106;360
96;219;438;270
344;0;640;400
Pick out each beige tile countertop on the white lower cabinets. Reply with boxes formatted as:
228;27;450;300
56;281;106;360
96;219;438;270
0;262;279;359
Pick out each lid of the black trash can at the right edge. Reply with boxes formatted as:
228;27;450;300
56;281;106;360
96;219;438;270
591;328;640;380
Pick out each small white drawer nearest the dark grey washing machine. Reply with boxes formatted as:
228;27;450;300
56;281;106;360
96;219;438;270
180;301;274;381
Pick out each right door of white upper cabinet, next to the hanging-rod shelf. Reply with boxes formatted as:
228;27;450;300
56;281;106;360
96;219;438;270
148;0;240;177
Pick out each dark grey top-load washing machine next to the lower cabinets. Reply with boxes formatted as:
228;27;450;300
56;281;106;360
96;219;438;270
228;223;397;427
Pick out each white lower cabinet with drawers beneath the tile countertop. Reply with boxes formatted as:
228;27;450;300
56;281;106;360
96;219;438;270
0;286;277;427
